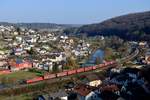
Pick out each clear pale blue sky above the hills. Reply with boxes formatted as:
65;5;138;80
0;0;150;24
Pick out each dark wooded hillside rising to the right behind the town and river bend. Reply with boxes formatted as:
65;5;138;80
78;11;150;40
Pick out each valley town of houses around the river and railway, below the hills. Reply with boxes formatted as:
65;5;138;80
0;25;150;100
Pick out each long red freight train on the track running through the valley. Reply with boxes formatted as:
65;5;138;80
25;61;117;84
